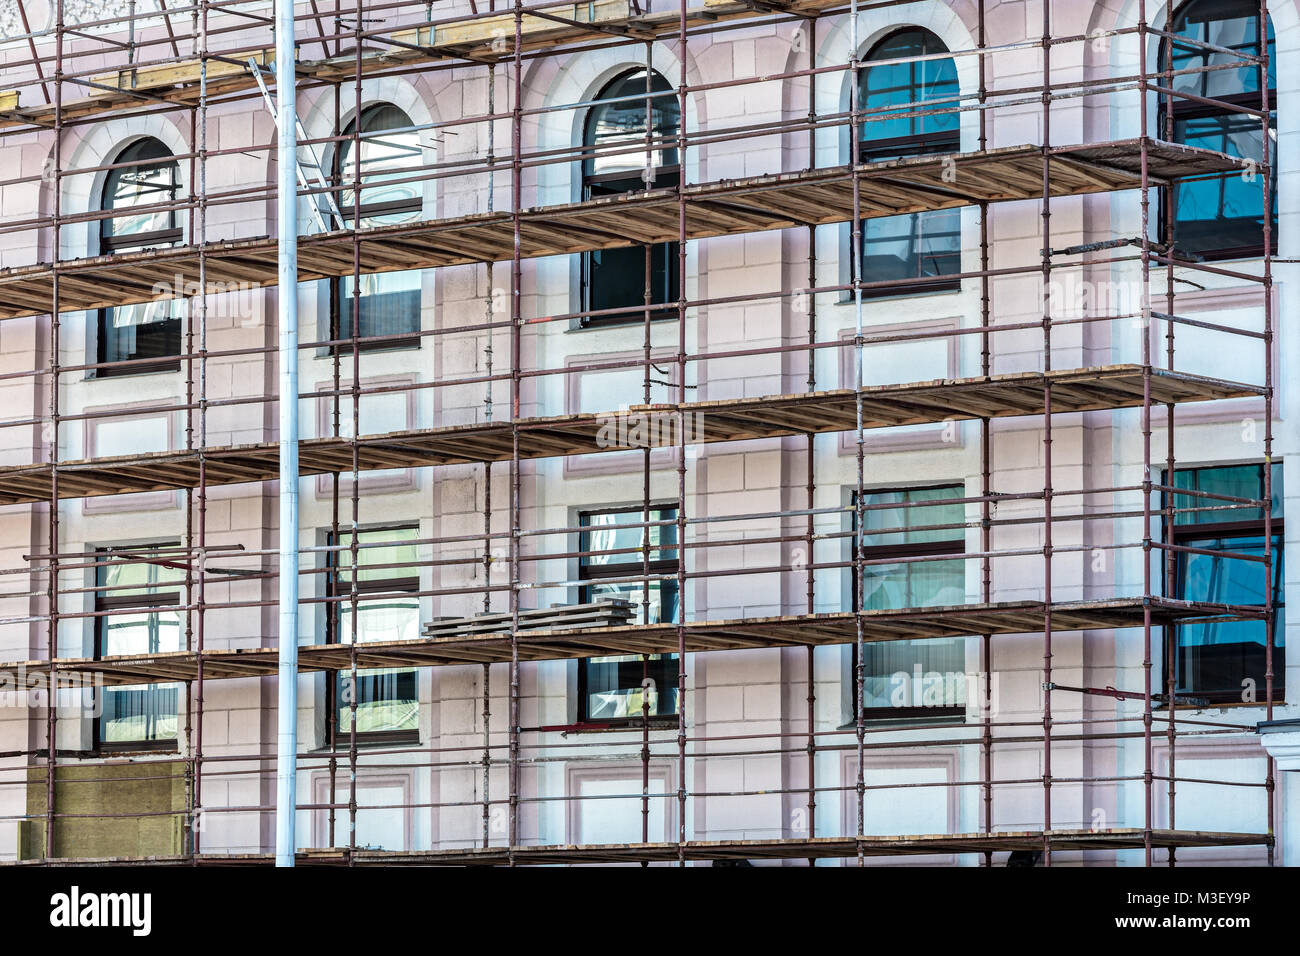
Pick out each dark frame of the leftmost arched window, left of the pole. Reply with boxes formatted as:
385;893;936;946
94;137;185;378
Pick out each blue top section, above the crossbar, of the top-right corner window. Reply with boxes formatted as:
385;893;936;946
1160;0;1278;100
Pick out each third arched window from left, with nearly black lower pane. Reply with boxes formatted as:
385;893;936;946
582;70;681;325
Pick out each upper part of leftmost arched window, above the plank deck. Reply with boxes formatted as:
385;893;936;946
100;138;181;252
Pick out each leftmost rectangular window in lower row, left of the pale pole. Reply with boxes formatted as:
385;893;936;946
95;545;185;750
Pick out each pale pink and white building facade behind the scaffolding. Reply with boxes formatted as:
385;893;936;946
0;0;1300;865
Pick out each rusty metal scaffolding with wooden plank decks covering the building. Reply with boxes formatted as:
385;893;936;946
0;0;1275;865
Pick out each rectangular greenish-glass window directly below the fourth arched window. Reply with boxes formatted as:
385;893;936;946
853;485;966;719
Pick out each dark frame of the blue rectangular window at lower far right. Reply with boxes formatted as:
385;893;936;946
1160;462;1287;706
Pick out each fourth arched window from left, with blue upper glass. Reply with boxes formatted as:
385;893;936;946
858;27;962;295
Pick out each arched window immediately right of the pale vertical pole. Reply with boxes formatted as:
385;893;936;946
330;103;424;349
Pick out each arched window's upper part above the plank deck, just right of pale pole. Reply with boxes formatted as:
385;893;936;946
335;103;423;226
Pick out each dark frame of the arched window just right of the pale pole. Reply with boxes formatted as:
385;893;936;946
325;101;424;355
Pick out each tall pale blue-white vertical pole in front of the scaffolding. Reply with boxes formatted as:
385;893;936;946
276;0;298;866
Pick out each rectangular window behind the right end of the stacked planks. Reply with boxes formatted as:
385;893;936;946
577;507;681;723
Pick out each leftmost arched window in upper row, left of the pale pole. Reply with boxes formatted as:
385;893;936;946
96;139;183;376
